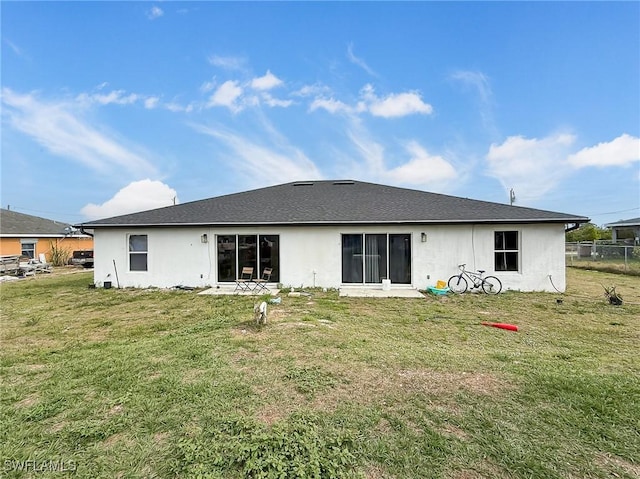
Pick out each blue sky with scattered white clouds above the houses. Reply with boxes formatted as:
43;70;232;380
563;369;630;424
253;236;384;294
0;2;640;225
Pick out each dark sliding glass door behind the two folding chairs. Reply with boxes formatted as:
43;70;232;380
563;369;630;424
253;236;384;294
217;235;280;283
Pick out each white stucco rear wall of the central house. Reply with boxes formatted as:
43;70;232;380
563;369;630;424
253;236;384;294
94;224;565;291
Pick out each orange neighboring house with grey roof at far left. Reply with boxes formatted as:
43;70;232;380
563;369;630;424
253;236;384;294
0;209;93;261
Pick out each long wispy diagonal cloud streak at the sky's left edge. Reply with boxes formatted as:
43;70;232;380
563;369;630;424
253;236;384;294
2;88;156;176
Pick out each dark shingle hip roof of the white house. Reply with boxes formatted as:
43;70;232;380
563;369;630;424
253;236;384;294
83;180;589;228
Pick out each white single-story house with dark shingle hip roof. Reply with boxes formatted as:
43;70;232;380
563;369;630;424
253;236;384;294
81;180;589;291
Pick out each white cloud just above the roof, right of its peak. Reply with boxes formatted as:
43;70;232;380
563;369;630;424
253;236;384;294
385;141;458;186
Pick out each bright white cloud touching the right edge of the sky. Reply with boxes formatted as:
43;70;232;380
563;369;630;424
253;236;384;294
569;133;640;168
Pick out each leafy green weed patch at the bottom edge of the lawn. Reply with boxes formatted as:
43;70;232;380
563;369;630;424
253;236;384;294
173;415;359;479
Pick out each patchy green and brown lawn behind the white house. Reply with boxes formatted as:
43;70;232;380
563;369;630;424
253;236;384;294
0;269;640;479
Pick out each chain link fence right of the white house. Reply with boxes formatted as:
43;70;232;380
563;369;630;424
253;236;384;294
565;241;640;271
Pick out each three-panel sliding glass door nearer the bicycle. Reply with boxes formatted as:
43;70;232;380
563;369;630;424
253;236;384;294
342;234;411;284
